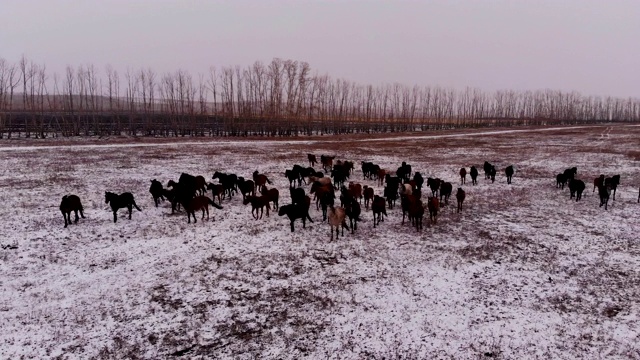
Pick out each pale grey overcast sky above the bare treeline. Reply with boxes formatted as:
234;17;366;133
0;0;640;98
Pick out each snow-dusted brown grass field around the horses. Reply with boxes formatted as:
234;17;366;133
0;125;640;359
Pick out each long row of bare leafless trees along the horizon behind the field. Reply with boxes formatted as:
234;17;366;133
0;57;640;137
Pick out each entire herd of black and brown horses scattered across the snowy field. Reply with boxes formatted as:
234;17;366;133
60;154;640;236
